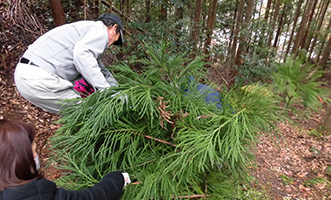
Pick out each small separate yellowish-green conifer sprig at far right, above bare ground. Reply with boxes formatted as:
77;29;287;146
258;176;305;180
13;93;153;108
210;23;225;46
271;56;328;111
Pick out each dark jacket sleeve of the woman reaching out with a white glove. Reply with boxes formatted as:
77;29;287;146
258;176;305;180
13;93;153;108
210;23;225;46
54;172;124;200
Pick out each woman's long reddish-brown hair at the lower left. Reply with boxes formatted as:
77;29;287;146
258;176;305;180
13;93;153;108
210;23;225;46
0;119;42;191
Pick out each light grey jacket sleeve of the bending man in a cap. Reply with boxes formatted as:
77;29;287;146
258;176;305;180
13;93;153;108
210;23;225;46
73;27;110;89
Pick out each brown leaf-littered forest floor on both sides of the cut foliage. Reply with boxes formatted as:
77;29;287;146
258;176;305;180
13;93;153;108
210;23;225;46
0;56;331;200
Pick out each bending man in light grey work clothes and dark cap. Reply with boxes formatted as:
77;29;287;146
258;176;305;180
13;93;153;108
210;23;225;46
14;14;123;113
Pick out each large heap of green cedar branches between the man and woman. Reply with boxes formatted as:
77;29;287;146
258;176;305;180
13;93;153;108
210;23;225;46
51;42;328;200
